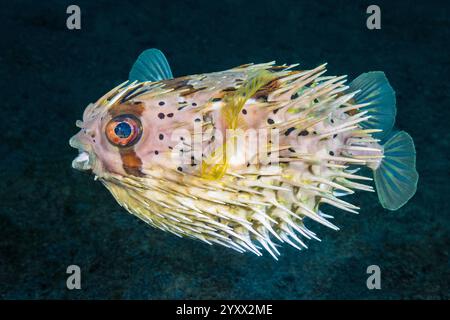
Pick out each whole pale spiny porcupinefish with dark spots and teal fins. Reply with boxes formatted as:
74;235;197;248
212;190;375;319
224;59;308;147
70;49;418;259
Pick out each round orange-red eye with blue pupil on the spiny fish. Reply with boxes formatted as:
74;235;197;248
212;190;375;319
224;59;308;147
105;114;142;147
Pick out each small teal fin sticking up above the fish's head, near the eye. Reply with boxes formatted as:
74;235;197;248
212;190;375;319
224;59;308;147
128;49;173;82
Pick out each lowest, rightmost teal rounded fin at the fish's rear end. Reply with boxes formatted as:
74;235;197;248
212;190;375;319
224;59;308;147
374;131;419;210
